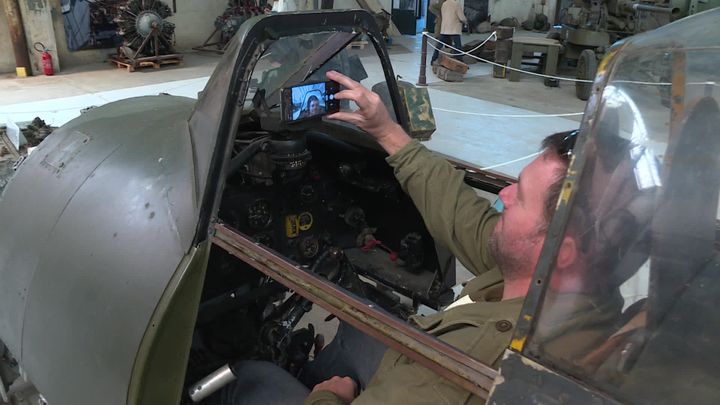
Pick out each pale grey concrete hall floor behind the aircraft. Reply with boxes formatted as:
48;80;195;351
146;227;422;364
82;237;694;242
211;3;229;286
0;34;585;176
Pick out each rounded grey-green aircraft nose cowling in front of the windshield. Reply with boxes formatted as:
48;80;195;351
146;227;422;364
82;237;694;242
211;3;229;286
0;96;199;404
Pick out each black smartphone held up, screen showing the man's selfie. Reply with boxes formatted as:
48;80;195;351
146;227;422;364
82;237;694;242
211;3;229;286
281;80;340;122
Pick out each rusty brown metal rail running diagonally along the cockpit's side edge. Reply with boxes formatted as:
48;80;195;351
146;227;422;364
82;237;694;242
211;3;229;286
212;224;497;398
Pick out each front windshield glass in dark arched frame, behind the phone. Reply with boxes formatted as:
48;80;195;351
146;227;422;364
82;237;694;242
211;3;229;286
244;32;394;125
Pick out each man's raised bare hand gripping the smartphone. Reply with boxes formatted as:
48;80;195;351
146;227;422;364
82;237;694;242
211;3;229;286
327;71;410;155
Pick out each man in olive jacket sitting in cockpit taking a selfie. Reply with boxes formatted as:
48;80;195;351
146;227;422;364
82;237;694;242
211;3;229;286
215;72;608;404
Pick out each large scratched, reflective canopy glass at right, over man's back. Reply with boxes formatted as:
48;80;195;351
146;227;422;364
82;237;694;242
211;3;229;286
525;12;720;404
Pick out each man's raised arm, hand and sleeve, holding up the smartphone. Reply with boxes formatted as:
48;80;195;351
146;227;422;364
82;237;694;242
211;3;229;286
328;72;499;274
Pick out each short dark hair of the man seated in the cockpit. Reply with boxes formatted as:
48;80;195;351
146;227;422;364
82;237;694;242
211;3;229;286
541;130;578;225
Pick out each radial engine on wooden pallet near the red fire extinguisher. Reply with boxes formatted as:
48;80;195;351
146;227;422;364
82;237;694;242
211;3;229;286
110;0;183;72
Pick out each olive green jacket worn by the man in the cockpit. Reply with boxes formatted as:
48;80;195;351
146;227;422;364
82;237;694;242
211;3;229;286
305;141;523;405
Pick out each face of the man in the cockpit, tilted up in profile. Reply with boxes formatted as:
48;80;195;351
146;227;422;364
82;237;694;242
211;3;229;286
490;154;565;280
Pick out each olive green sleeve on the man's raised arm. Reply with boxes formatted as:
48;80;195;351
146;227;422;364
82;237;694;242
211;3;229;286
387;140;499;275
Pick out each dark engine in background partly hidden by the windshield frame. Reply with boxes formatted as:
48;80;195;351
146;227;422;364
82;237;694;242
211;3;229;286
193;0;270;54
